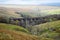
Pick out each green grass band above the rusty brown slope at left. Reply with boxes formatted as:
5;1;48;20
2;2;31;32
0;23;28;33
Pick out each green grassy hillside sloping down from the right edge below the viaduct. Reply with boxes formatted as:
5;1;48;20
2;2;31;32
30;20;60;40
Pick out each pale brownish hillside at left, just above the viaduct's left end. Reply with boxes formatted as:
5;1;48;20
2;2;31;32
0;7;21;18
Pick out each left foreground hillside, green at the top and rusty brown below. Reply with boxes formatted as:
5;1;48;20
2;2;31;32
0;23;39;40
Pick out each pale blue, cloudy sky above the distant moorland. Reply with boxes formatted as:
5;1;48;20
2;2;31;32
0;0;60;5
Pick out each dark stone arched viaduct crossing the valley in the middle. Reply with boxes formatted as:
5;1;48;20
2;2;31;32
11;17;46;27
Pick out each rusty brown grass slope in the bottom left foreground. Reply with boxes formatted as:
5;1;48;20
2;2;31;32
0;30;39;40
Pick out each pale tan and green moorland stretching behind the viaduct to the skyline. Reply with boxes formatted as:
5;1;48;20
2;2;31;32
0;5;60;17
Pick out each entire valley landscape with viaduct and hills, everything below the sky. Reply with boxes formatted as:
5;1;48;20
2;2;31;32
0;4;60;40
